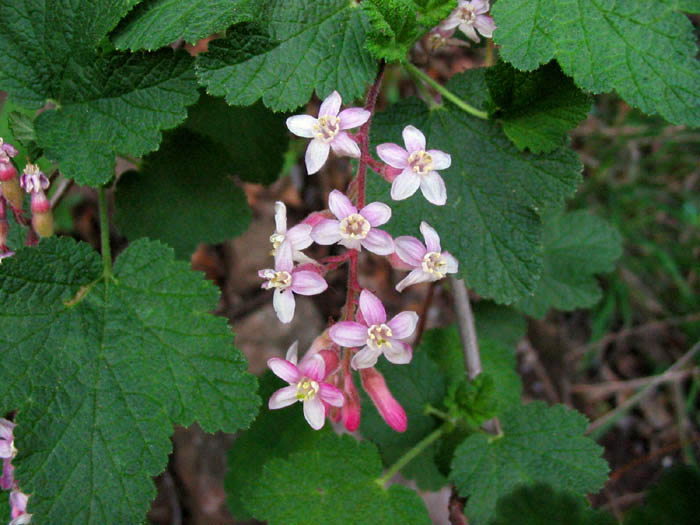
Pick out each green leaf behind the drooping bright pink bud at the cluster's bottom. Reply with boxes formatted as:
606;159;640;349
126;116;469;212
360;351;446;490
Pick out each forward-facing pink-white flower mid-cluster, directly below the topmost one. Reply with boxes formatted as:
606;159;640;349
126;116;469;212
311;190;394;255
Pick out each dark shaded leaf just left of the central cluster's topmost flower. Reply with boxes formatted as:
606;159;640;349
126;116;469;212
185;95;289;184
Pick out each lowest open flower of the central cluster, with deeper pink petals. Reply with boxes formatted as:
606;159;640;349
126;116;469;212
267;342;345;430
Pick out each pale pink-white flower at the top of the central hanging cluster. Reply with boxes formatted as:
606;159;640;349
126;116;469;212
287;91;370;175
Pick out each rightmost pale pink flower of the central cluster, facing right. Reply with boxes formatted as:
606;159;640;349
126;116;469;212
394;221;459;292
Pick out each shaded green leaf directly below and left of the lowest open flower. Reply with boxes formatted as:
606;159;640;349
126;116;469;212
225;373;331;520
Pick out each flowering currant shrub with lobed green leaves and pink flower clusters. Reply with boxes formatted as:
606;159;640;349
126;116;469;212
0;0;700;525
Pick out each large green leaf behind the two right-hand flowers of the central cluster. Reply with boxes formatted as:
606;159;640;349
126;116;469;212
368;70;581;303
